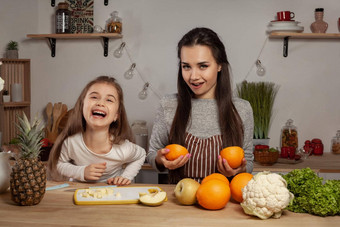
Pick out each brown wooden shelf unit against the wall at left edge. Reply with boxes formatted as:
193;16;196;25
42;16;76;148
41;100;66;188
0;58;31;143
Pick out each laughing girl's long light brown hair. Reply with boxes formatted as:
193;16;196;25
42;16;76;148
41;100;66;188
48;76;134;180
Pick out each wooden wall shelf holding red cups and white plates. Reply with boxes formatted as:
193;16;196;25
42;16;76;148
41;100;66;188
269;32;340;57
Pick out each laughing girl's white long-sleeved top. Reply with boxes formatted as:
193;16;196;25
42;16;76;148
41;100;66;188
57;133;146;182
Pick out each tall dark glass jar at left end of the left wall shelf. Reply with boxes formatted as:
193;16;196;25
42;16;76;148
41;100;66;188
55;2;71;34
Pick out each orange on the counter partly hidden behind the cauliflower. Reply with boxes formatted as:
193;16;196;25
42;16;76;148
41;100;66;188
229;173;253;203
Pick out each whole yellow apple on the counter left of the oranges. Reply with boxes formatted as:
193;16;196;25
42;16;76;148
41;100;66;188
174;178;200;205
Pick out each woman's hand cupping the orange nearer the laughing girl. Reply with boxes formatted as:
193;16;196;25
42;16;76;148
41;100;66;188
156;148;190;170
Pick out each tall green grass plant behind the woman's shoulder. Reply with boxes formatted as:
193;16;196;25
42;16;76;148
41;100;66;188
236;81;278;145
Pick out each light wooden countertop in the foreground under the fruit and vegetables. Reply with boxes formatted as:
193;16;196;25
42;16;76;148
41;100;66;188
0;181;340;227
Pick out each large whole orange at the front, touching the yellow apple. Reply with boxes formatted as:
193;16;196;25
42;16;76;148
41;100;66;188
196;179;230;210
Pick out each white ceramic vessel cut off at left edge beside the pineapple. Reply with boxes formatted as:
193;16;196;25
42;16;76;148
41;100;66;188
0;152;11;193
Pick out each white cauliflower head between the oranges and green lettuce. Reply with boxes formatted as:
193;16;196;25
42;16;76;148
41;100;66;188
241;171;294;219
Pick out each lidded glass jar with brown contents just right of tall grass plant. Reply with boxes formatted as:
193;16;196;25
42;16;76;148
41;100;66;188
281;119;298;149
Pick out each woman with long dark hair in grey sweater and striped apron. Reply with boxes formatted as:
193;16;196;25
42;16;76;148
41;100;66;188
147;28;254;183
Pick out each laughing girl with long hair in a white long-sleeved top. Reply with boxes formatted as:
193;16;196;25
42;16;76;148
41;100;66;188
48;76;145;185
